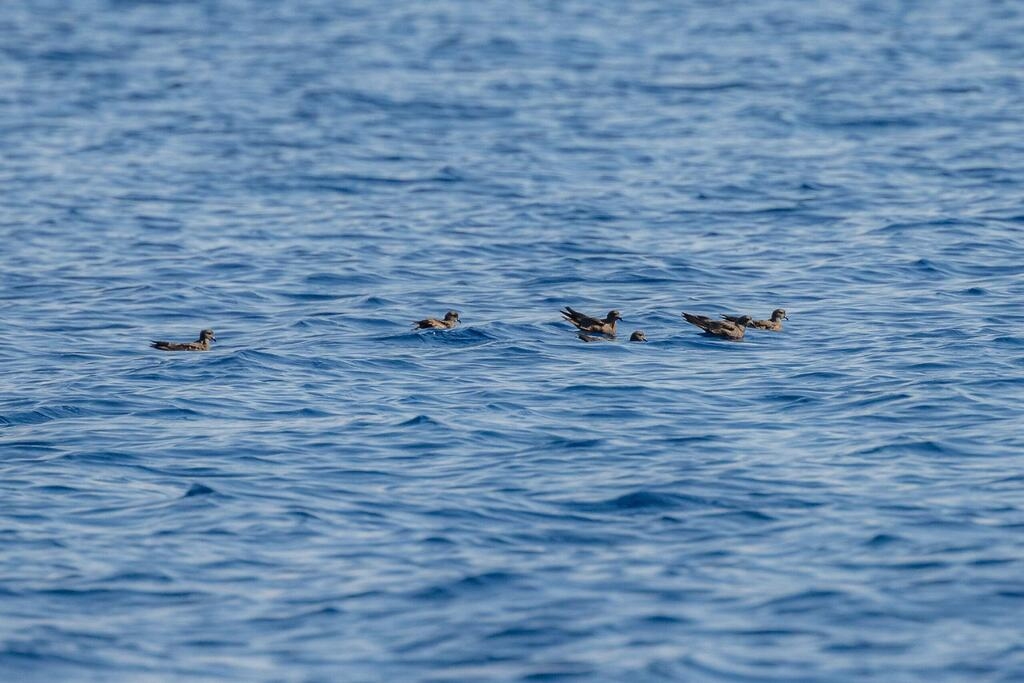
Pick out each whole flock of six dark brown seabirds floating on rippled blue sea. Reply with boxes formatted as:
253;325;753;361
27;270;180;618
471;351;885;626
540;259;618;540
150;306;790;351
